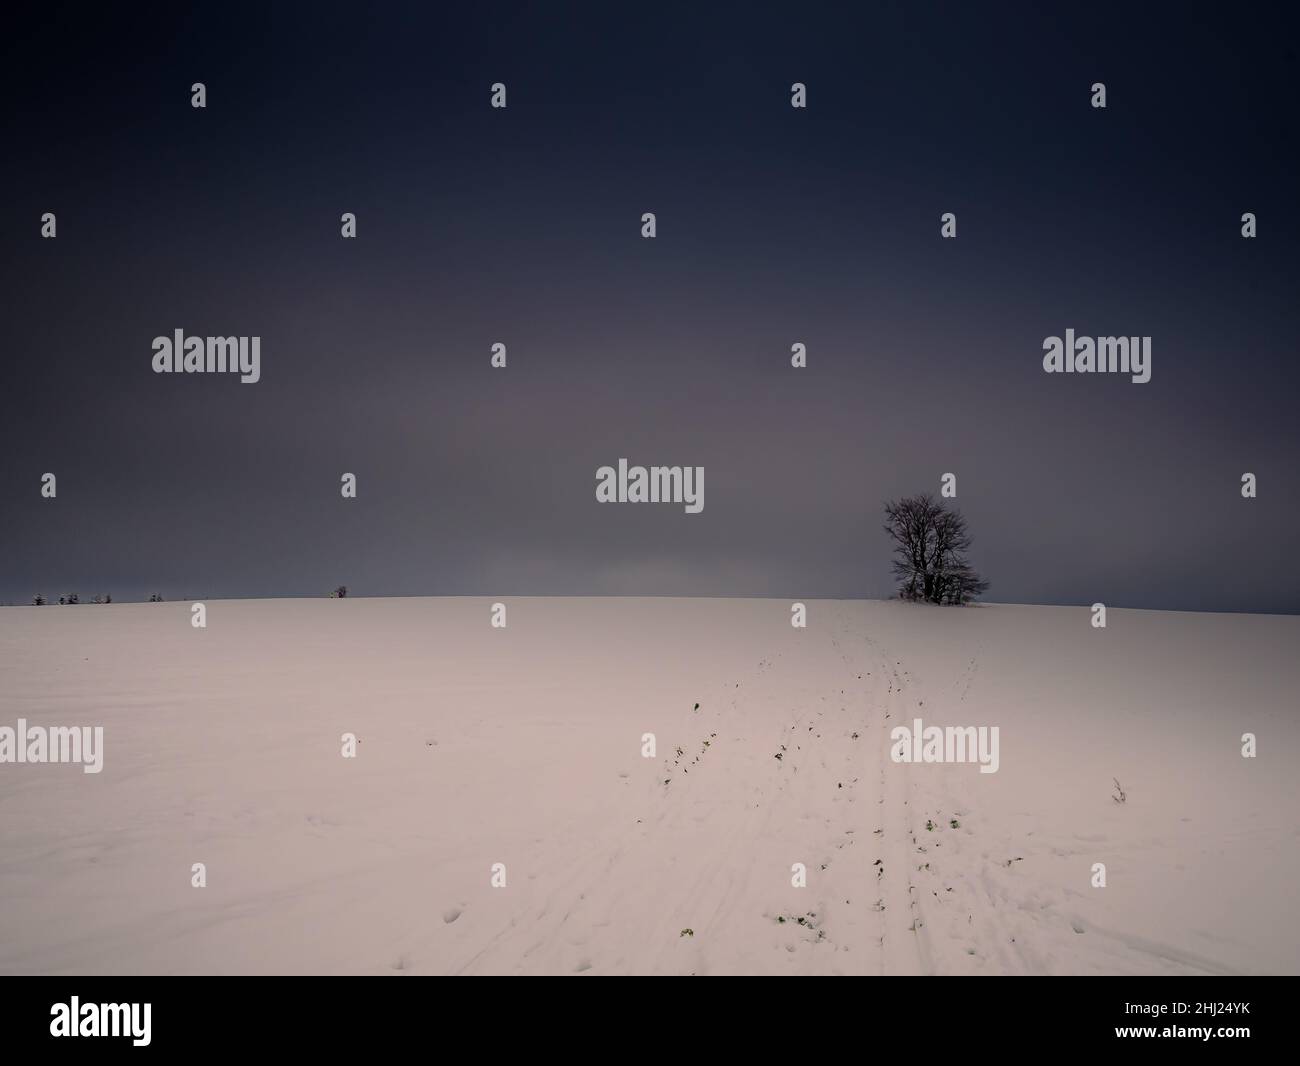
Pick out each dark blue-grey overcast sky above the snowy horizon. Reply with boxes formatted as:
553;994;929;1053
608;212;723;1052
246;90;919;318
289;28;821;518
0;4;1300;611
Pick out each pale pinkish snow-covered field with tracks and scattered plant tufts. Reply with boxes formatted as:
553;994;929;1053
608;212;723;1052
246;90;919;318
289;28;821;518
0;598;1300;975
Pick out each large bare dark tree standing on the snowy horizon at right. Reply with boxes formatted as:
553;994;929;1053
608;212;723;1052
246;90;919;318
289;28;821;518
885;494;988;603
